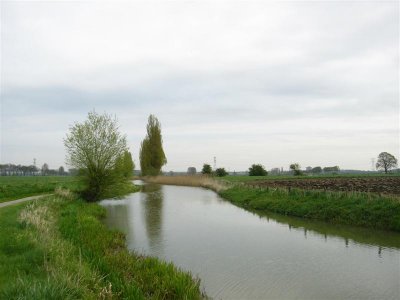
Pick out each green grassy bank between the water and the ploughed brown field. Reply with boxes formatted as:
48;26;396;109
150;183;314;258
220;185;400;231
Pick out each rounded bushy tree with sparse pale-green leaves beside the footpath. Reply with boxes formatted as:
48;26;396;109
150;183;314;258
64;111;127;201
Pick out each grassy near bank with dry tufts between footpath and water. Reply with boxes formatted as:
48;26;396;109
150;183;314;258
0;190;202;299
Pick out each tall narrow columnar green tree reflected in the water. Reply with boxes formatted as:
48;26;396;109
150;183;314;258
139;115;167;176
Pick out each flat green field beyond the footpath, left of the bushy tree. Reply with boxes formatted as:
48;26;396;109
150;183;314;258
0;176;83;202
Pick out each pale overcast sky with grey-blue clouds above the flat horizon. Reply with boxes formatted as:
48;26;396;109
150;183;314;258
0;1;400;171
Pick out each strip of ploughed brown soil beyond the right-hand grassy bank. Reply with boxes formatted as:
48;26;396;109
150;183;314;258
247;176;400;195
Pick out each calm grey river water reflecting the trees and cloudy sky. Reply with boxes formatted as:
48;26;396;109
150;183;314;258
101;185;400;299
